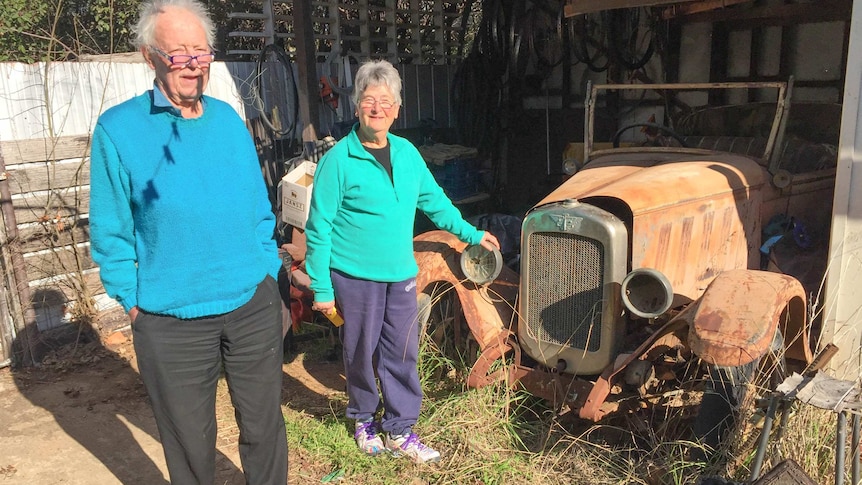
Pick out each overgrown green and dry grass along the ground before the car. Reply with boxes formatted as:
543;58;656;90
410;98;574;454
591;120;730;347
285;316;852;485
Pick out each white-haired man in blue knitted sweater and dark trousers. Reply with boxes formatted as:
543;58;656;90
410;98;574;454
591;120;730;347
90;0;287;485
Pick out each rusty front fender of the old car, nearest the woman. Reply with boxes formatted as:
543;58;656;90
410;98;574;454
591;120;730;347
413;231;518;351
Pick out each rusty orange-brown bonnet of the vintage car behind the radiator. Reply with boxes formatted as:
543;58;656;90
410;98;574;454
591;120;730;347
536;150;768;304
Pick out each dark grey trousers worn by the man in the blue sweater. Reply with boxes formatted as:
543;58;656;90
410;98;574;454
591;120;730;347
132;276;287;485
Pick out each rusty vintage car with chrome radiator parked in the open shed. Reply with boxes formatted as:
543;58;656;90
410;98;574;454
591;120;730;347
414;81;840;434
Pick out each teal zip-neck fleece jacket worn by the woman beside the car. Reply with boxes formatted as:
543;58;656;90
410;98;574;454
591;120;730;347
305;125;484;302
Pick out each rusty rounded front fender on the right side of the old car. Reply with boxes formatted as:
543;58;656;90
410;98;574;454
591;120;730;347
688;270;812;367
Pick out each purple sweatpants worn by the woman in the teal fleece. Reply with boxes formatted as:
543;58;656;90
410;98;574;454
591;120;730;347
331;271;422;434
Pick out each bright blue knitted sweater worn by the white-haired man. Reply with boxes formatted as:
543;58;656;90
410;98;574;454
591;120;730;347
90;89;281;318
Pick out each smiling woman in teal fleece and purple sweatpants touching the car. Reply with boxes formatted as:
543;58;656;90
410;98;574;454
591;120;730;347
306;61;499;463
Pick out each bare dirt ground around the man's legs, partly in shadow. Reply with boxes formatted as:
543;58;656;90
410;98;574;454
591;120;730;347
0;310;344;485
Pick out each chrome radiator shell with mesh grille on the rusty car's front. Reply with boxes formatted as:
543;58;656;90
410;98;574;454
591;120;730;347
518;201;628;375
